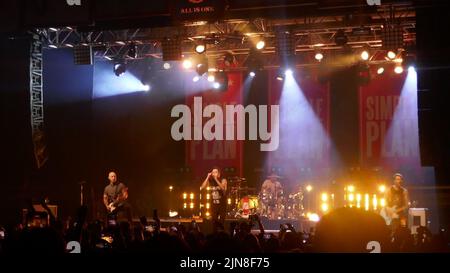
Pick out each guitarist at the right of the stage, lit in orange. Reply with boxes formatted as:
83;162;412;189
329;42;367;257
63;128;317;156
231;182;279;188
386;173;409;230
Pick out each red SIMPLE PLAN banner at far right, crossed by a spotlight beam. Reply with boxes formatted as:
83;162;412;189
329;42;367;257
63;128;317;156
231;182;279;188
360;66;420;169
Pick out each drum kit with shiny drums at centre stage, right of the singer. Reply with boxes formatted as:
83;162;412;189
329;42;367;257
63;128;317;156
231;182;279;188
227;177;304;219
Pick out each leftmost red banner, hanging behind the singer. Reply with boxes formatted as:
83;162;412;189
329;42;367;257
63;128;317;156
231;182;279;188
186;72;243;178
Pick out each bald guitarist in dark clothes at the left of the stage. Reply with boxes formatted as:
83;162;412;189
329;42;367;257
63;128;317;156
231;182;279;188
103;171;131;221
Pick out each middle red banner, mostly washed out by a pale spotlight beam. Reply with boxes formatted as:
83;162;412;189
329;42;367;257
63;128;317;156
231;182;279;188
267;69;330;177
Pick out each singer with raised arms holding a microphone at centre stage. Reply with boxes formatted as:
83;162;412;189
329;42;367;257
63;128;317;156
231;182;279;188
200;167;227;230
